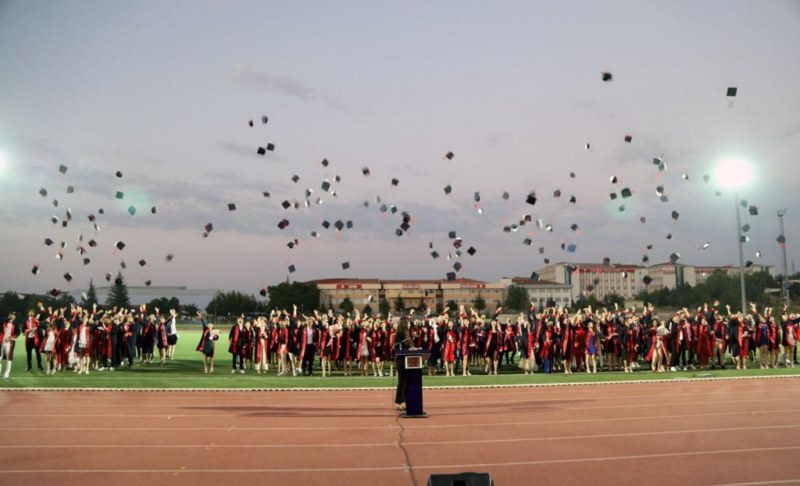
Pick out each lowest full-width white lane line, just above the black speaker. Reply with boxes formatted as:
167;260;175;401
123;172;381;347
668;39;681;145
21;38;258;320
3;446;800;474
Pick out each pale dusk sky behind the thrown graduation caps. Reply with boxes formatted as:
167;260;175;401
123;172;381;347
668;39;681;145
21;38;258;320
0;0;800;293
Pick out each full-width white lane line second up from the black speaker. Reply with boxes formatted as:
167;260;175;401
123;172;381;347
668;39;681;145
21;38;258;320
0;424;800;450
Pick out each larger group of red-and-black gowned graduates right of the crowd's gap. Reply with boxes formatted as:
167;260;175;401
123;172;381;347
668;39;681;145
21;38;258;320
197;302;800;377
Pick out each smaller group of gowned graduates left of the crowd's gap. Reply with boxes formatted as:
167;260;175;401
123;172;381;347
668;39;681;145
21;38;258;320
0;303;178;378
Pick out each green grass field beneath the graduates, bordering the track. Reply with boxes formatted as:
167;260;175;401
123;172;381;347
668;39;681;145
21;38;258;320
0;330;800;389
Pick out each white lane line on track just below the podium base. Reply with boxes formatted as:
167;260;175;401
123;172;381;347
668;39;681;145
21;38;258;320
3;409;800;432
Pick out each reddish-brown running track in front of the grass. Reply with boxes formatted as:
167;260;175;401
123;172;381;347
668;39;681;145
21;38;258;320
0;378;800;486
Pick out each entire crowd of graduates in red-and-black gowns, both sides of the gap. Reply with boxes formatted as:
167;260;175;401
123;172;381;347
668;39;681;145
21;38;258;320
0;302;800;378
